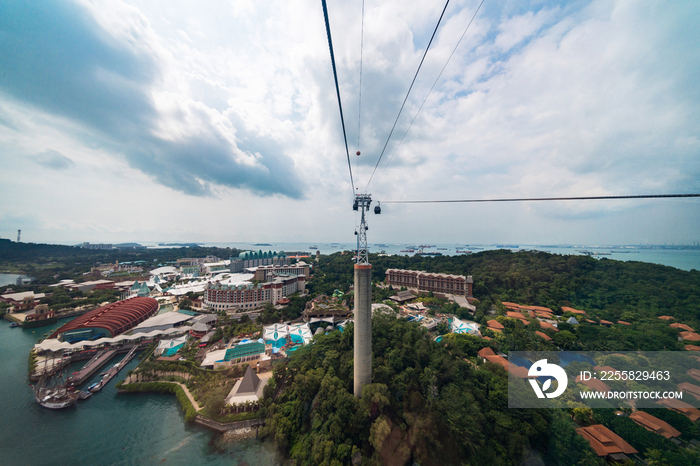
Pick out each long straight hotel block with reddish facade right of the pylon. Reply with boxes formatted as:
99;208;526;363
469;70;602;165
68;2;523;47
386;269;474;298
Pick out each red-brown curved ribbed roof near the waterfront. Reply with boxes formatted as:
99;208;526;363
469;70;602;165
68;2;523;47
49;297;158;338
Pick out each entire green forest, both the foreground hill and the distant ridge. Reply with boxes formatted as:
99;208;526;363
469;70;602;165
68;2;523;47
262;251;700;466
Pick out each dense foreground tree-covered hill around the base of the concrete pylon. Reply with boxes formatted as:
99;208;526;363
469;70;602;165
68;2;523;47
261;315;605;465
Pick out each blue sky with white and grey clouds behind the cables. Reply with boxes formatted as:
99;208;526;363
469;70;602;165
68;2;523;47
0;0;700;244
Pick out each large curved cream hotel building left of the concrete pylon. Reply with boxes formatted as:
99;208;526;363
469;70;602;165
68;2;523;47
202;275;306;311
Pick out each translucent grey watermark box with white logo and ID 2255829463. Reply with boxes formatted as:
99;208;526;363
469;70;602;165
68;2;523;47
508;351;700;410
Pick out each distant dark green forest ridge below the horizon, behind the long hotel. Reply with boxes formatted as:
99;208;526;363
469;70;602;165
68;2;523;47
310;250;700;340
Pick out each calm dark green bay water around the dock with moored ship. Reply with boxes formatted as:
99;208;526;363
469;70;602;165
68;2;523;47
0;320;280;466
